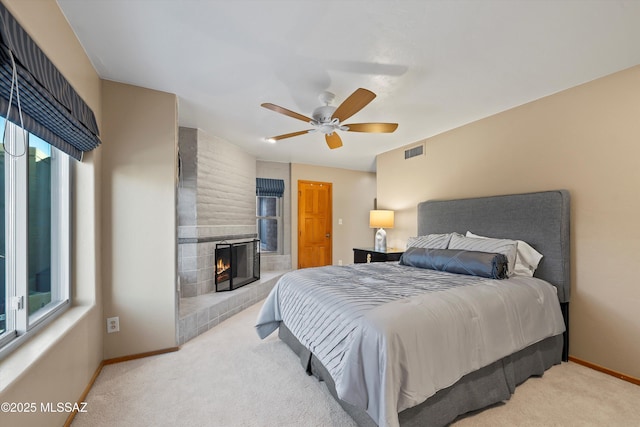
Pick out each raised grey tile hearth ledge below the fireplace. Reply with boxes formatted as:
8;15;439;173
178;271;286;345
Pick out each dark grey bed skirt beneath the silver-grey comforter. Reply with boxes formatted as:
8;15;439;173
278;323;563;427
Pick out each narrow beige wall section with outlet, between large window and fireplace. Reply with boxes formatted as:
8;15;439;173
102;81;178;359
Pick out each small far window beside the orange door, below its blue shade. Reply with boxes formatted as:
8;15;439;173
256;196;282;254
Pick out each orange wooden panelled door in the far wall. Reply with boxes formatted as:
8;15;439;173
298;181;333;268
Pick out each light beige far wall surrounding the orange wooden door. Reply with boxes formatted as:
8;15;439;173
291;163;376;269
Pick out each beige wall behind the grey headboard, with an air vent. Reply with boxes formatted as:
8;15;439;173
377;66;640;378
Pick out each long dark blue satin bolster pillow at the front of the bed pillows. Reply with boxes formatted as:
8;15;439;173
400;247;508;279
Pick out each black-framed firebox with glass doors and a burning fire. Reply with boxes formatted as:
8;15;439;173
214;239;260;292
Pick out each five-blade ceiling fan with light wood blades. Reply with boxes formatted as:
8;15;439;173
262;88;398;149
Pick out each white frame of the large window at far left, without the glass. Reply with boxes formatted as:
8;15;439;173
0;121;72;358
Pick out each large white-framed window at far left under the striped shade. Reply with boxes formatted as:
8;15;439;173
0;118;71;355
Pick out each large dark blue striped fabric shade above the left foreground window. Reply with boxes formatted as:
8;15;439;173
0;3;100;160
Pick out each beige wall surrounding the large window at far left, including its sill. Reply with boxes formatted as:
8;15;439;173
0;0;103;427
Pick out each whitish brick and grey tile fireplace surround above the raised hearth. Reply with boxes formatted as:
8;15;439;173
178;127;256;298
